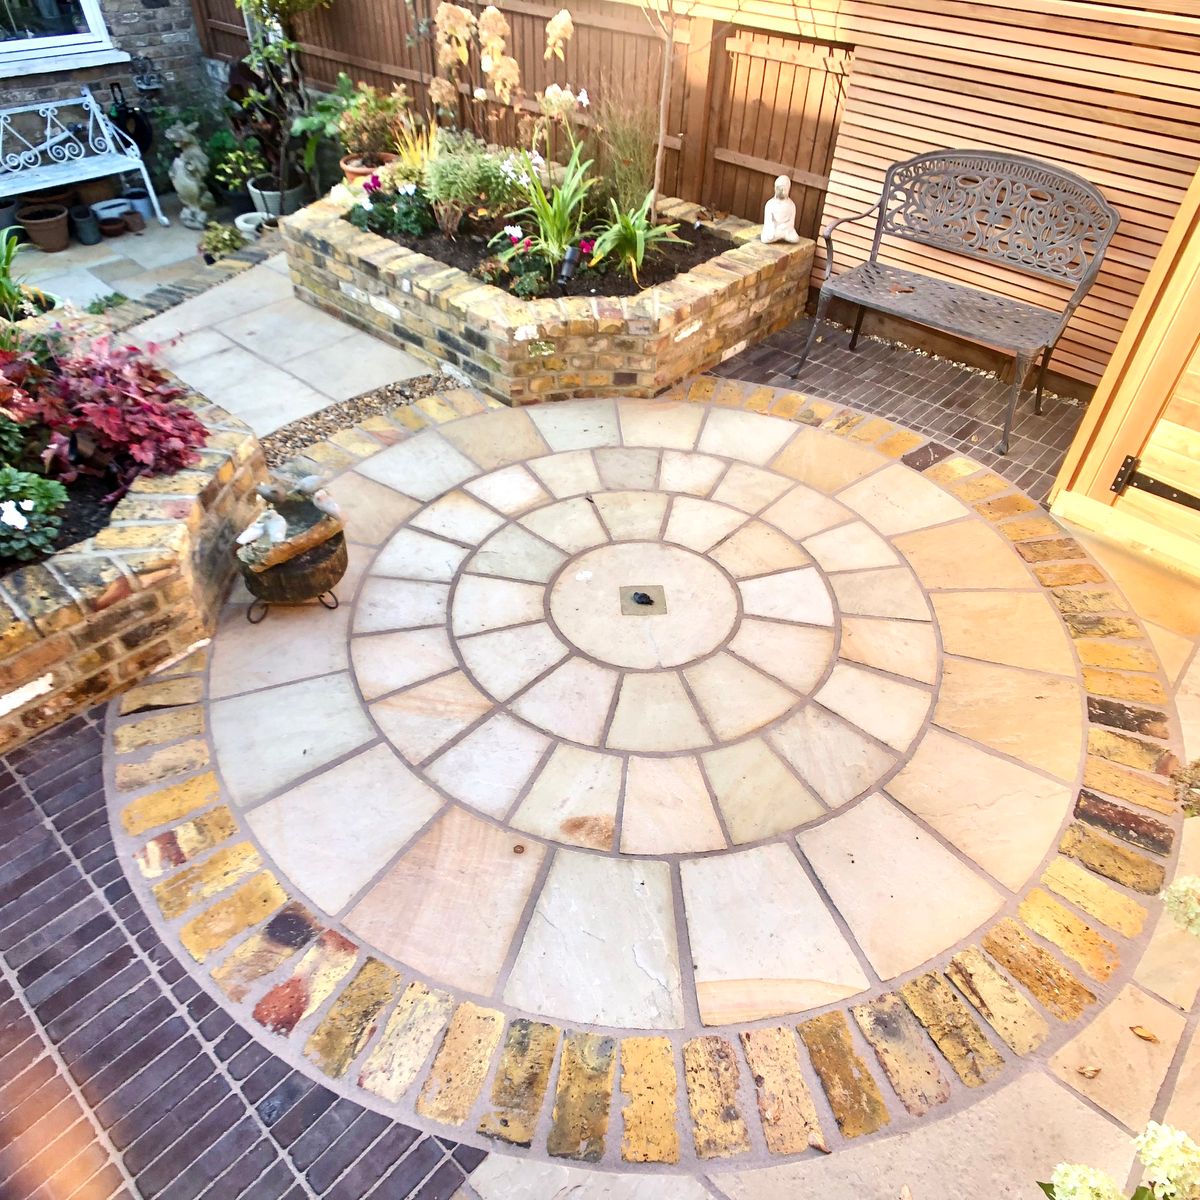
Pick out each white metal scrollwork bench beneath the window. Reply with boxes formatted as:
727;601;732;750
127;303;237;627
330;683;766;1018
0;88;170;224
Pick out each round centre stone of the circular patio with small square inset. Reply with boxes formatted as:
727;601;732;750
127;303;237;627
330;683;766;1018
550;542;738;671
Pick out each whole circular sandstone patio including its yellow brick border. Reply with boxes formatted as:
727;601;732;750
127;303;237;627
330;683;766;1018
109;391;1190;1180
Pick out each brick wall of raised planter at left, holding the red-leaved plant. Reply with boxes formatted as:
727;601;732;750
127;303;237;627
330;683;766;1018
0;333;266;754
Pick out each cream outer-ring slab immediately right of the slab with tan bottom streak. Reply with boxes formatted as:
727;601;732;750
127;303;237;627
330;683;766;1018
799;796;1004;979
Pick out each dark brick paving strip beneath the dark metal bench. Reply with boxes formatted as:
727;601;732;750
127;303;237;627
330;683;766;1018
712;317;1087;500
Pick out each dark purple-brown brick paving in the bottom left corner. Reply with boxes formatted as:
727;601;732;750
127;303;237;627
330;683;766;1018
0;709;484;1200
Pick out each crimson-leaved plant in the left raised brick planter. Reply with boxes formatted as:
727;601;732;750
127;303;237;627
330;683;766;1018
0;337;208;502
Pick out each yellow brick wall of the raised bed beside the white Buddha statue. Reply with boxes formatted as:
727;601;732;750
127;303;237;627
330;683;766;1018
283;199;814;404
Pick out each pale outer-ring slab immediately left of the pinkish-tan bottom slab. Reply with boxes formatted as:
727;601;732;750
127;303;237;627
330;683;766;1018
247;745;443;912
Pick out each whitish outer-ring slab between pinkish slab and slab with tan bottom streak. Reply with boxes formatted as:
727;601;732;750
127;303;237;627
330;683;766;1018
504;850;683;1030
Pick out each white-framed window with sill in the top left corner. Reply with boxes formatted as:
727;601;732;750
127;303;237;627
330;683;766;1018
0;0;128;76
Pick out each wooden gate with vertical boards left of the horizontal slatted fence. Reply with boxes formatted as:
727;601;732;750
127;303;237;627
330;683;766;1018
702;29;851;238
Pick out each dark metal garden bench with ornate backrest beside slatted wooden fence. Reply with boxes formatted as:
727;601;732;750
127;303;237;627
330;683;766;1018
797;150;1121;454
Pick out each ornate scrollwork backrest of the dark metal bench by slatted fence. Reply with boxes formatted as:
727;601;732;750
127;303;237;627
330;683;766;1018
871;150;1121;295
